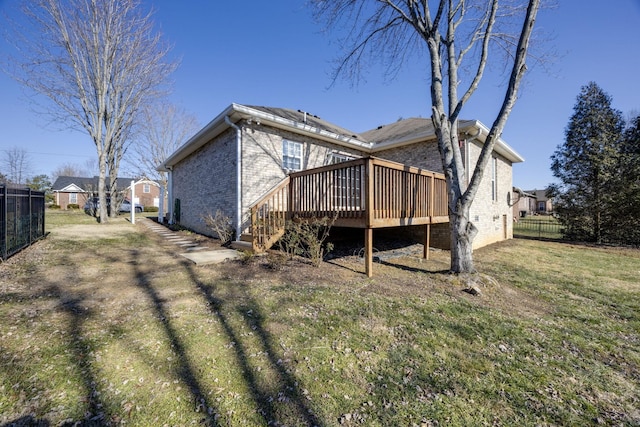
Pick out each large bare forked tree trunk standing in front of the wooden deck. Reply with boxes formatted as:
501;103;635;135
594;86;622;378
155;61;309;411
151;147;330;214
312;0;540;273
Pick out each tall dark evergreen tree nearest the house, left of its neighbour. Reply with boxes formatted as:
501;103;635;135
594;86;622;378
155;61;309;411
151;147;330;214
551;82;624;243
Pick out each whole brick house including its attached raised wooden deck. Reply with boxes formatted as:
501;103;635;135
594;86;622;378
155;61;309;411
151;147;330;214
158;104;523;274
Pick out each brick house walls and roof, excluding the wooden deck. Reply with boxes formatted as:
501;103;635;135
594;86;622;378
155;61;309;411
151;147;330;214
158;104;523;248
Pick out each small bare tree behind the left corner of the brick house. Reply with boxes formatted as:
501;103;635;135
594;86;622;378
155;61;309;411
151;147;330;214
128;103;200;197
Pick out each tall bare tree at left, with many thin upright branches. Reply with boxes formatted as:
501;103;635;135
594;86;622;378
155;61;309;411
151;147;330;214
8;0;176;222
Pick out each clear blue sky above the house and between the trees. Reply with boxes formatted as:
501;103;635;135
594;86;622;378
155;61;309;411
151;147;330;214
0;0;640;190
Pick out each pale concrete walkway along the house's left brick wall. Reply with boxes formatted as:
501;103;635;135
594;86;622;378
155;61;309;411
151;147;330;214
138;218;241;265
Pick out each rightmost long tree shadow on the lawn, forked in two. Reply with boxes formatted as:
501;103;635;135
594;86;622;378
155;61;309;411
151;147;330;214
182;261;324;427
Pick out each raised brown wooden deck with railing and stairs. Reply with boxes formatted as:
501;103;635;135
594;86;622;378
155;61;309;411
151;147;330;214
251;157;449;276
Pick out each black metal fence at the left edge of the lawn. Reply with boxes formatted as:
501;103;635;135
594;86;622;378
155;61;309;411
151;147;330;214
0;185;44;261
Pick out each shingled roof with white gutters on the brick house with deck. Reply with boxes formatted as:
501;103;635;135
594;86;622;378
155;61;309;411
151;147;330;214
157;104;524;171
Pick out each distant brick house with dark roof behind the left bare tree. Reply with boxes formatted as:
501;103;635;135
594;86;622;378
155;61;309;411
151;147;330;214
51;176;160;209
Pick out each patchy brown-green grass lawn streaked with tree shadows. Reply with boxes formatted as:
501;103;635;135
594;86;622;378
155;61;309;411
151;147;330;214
0;212;640;427
